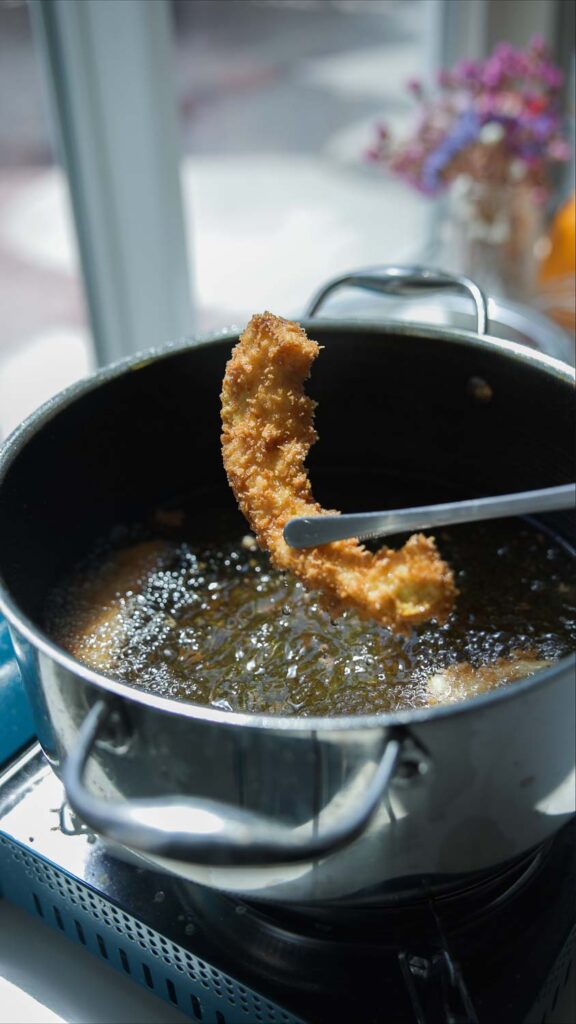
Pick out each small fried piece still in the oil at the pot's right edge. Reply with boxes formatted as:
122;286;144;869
426;651;551;705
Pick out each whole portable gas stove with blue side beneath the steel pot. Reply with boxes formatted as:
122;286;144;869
0;610;576;1024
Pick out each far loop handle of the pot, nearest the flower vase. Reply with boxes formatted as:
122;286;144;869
305;266;488;335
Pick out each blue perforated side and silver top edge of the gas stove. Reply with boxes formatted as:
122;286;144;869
0;618;302;1024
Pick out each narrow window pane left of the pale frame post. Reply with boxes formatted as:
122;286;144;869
0;2;91;438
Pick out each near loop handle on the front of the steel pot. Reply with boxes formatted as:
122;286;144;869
61;700;406;866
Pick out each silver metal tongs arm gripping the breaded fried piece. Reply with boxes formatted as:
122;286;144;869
284;483;576;548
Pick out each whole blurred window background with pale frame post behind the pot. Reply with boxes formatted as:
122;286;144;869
0;0;574;434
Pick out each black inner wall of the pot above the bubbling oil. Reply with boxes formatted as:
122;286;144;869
0;325;574;624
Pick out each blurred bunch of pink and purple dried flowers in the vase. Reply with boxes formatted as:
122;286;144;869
368;37;569;195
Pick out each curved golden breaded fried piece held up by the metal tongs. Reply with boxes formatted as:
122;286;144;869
221;312;456;633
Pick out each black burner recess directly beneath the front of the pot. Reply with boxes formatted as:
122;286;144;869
181;846;549;986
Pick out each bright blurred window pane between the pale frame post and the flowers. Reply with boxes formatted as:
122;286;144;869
173;0;429;327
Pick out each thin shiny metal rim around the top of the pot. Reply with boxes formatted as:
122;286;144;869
0;317;576;733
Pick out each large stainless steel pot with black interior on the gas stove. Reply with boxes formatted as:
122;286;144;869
0;268;575;904
